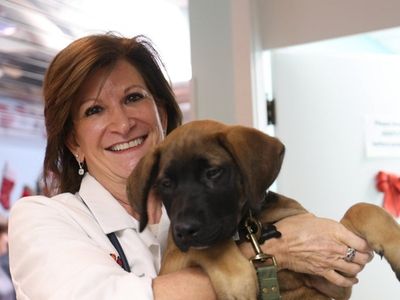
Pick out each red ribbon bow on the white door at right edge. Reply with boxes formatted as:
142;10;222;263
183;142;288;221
376;171;400;218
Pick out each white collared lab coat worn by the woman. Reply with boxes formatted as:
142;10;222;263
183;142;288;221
9;174;169;300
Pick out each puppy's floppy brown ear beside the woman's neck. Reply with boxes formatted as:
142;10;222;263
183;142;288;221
127;148;160;232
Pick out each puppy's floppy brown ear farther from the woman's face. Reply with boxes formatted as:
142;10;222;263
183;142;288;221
219;126;285;211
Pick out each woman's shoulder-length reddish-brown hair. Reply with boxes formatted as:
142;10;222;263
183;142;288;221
43;33;182;195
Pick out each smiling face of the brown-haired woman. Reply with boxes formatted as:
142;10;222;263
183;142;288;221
69;60;167;183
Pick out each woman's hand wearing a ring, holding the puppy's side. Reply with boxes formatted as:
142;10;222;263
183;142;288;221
262;214;373;287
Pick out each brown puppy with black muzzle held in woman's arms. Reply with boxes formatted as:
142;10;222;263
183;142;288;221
128;121;400;300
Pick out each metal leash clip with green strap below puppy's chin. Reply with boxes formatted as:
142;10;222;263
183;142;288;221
245;214;281;300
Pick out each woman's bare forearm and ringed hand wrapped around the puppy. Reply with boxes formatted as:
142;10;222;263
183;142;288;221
153;214;372;300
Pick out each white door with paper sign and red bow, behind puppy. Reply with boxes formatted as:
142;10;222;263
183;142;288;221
271;50;400;300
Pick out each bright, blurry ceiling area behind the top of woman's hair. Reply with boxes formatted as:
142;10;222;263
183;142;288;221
0;0;190;103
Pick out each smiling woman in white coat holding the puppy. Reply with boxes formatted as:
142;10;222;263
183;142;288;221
10;34;370;300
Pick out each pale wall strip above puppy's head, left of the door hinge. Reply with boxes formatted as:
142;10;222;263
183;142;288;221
189;0;263;126
